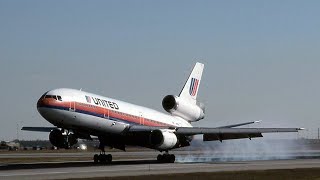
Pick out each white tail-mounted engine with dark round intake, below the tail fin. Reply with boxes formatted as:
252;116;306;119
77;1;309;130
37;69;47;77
162;95;204;121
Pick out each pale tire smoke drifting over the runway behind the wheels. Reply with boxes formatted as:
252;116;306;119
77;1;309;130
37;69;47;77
176;138;312;162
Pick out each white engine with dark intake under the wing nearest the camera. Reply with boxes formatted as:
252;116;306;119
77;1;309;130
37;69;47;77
150;130;178;150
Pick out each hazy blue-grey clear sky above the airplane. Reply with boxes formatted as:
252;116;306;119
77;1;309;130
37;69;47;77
0;0;320;140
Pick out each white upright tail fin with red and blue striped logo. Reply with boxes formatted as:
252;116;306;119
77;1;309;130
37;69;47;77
179;62;204;103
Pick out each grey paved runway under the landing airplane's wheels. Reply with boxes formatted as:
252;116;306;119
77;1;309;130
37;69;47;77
0;159;320;179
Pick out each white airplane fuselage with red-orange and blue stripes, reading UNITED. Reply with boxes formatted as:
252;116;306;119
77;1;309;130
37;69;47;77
37;88;192;138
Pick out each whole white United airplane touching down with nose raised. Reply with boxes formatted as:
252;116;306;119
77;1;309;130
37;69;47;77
22;63;302;163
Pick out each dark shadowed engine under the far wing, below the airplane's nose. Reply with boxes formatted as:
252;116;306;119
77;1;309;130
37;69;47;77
49;129;78;148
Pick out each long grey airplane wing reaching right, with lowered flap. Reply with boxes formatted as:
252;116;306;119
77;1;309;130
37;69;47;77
128;126;303;141
